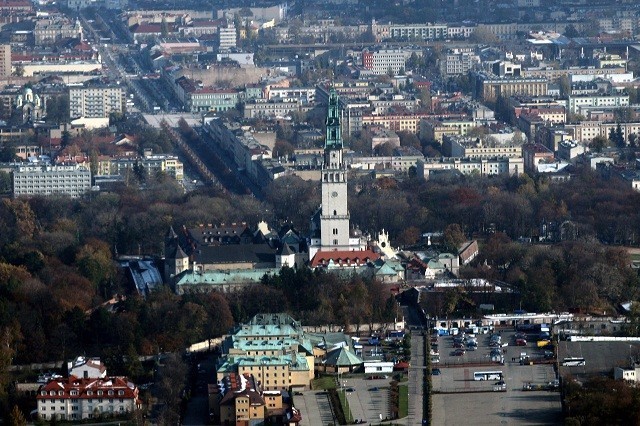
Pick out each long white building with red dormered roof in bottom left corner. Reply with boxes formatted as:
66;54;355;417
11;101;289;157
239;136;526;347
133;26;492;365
36;376;141;420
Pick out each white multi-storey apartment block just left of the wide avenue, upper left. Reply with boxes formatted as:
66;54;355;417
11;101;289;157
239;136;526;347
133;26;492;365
69;85;126;119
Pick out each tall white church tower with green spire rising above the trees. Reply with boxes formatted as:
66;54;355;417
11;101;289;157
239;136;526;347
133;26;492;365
320;89;350;251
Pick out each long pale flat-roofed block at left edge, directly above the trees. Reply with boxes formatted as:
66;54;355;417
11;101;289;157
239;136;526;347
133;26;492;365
12;165;91;197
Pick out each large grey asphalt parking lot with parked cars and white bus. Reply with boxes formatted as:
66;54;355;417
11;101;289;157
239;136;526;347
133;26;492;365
432;330;561;425
